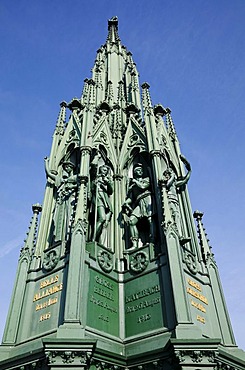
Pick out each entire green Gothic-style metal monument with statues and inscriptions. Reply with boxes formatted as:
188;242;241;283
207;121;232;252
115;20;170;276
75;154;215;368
0;17;245;370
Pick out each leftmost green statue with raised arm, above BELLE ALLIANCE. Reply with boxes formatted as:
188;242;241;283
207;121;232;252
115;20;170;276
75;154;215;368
45;157;79;242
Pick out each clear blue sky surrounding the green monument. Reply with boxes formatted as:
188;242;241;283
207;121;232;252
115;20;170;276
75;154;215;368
0;0;245;349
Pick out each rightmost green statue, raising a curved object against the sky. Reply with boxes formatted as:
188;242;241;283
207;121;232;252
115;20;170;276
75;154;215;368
163;155;191;245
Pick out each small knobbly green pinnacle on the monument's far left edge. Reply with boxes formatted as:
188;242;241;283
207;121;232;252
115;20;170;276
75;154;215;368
20;203;42;258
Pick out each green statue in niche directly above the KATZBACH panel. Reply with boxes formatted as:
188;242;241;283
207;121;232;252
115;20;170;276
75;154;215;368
122;163;154;248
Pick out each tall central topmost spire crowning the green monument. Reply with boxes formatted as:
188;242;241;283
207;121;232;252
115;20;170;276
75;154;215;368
88;17;140;108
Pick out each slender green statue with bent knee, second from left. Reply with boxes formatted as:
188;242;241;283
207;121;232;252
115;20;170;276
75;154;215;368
91;153;113;246
